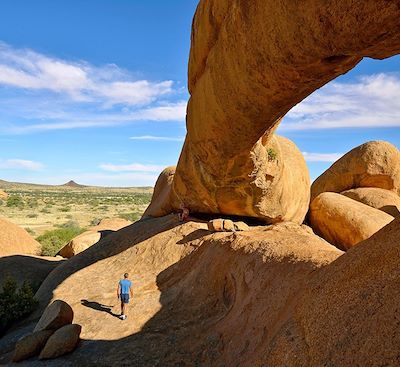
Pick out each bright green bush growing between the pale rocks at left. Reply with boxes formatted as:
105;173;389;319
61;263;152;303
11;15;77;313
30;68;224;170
36;222;84;256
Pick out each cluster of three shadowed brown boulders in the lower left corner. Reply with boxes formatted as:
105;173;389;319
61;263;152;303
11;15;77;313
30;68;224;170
13;300;82;362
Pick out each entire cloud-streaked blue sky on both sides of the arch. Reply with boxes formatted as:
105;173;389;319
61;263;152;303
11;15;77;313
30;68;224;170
0;0;400;186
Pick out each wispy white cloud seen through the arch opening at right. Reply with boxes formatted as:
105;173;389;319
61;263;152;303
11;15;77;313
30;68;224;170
280;73;400;131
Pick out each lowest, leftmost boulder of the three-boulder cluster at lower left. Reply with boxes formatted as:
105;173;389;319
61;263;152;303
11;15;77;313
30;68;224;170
13;330;53;362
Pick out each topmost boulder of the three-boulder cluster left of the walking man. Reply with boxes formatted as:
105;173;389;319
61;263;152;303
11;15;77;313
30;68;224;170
34;299;74;332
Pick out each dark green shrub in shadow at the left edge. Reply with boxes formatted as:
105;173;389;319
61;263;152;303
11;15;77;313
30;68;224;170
0;277;38;335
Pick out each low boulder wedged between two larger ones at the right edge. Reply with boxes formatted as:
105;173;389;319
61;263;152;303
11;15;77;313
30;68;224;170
341;188;400;217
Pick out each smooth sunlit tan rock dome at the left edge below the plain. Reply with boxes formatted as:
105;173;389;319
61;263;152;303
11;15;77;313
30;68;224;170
0;218;41;257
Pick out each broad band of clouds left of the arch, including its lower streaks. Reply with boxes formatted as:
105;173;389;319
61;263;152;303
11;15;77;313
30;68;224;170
0;41;187;135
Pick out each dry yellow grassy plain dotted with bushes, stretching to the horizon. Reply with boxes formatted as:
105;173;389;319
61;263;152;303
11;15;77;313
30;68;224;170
0;181;153;237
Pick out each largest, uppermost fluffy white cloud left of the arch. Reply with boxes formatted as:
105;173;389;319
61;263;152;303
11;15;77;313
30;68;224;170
0;42;173;106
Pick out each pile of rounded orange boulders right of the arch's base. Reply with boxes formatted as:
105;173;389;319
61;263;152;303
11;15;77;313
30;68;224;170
309;141;400;250
